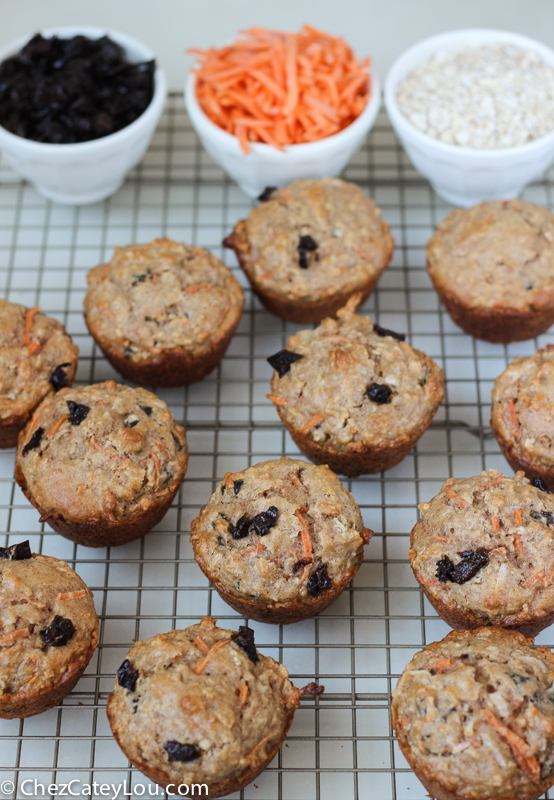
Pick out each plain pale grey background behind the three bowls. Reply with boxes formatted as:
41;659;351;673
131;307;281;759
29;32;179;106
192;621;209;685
0;0;554;89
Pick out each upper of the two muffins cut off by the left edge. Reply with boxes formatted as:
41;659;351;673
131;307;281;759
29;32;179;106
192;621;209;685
0;300;79;447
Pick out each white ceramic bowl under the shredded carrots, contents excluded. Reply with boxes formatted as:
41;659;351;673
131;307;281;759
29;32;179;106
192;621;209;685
185;72;381;197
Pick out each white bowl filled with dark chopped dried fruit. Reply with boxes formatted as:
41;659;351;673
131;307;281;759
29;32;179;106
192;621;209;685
0;27;167;205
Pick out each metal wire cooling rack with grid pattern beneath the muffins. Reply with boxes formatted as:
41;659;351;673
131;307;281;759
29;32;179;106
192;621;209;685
0;96;554;800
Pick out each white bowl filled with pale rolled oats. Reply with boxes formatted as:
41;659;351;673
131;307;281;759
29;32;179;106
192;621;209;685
384;29;554;207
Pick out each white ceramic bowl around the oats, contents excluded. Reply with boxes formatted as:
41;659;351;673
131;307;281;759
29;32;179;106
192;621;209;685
384;29;554;207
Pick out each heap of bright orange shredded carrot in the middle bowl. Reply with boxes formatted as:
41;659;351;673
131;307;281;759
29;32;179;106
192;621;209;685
189;25;370;154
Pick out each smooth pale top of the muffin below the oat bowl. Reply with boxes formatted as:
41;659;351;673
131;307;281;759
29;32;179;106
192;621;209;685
427;200;554;310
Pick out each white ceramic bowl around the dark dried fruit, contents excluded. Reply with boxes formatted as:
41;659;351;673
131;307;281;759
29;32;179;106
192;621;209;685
0;26;167;205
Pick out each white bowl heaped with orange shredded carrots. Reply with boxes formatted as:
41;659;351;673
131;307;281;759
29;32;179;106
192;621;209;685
185;25;380;197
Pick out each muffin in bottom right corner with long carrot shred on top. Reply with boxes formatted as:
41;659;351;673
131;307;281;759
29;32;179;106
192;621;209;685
391;628;554;800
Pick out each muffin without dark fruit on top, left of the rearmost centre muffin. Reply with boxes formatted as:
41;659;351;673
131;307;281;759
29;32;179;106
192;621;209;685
85;239;244;386
